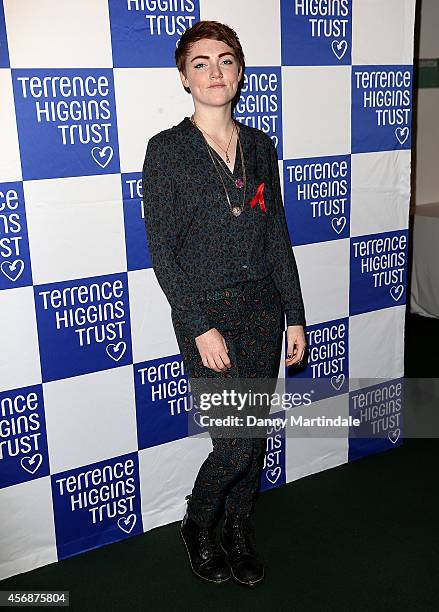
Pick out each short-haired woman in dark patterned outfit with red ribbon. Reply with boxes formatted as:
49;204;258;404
142;21;306;586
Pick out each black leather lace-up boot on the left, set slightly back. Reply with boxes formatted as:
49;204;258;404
180;495;230;583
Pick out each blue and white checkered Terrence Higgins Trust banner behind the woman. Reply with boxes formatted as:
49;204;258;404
0;0;415;578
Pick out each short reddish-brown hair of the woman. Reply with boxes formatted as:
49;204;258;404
175;21;245;89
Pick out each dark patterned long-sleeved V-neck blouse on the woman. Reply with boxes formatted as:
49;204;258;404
142;117;305;337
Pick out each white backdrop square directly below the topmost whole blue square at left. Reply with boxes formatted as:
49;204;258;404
23;174;127;285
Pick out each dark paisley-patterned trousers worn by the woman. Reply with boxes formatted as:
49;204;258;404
172;276;285;527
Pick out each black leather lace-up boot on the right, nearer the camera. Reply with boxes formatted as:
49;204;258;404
220;513;265;586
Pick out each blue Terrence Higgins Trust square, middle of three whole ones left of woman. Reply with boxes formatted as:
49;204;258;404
34;274;132;382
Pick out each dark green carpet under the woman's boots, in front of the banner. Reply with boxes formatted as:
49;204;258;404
0;316;439;612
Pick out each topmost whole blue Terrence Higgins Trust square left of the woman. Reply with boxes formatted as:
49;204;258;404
12;69;120;180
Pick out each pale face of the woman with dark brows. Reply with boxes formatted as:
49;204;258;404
180;38;241;106
